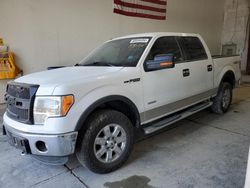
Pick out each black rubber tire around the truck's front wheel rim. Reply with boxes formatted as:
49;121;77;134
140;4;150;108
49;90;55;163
76;110;134;174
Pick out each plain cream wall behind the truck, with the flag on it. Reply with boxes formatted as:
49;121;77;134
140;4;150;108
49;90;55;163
0;0;224;102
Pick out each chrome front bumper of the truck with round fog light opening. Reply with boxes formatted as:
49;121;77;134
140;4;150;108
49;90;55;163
4;124;78;157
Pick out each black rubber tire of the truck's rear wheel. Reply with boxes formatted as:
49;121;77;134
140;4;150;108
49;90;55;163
211;82;233;114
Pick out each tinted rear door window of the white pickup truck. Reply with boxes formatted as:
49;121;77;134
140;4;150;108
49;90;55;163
179;37;208;61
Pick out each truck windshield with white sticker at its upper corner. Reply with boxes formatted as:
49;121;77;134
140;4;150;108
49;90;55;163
77;37;151;67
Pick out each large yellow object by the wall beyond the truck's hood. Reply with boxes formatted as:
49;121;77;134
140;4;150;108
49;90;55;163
0;52;22;80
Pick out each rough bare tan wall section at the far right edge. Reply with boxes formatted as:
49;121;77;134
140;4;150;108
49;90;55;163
222;0;250;70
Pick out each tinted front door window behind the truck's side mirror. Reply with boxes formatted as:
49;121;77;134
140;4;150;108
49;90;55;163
146;37;183;63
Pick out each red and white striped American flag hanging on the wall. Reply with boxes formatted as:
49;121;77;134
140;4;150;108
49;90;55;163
114;0;167;20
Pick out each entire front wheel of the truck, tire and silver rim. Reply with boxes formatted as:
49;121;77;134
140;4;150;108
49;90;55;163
76;110;134;174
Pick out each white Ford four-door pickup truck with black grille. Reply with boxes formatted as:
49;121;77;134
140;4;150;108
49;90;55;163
3;33;241;173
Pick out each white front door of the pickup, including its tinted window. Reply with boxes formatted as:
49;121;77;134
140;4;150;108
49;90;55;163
142;36;190;123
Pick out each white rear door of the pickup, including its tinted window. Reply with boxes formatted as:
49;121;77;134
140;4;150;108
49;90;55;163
177;37;213;97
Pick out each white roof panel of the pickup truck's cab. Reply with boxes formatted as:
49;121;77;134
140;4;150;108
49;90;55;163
113;32;200;40
